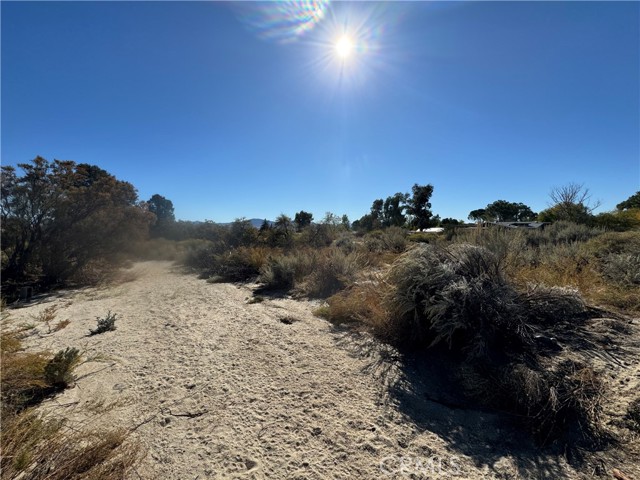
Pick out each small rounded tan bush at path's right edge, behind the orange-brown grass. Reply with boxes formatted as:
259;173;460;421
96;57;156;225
302;248;361;298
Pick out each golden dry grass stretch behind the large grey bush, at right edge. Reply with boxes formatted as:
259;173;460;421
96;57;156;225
482;230;640;312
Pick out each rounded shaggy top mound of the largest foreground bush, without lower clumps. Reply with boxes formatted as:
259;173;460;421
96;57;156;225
380;245;513;346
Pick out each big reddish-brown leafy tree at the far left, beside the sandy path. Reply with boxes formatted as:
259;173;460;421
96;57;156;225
1;157;153;285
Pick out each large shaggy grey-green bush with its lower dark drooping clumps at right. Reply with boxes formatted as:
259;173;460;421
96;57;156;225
377;244;604;442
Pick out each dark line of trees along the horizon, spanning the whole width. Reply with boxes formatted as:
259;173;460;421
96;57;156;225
0;157;640;295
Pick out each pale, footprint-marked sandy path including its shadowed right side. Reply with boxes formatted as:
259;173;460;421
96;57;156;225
10;262;640;479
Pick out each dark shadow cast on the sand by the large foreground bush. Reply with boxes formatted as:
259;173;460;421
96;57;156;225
334;326;592;479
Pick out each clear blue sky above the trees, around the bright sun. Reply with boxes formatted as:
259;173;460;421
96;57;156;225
0;1;640;222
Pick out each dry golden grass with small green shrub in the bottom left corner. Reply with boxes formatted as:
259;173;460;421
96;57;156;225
0;332;141;480
